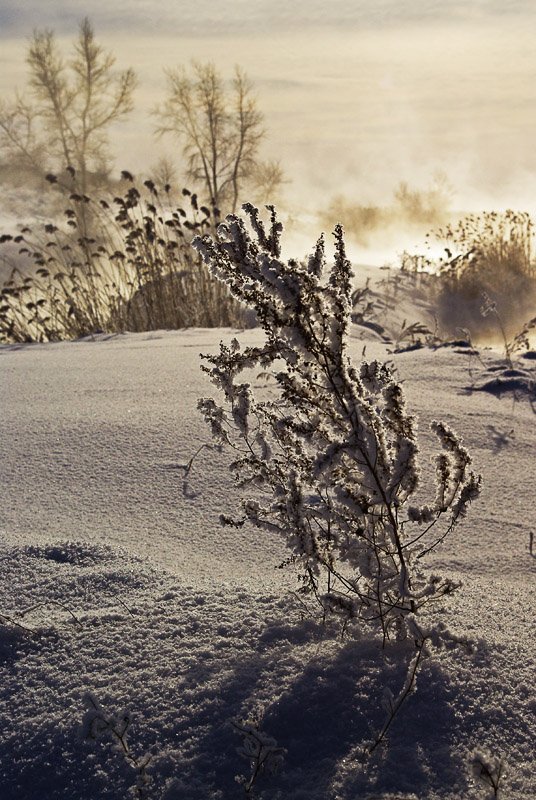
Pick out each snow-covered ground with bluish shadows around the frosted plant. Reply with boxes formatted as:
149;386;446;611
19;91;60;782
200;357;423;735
0;328;536;800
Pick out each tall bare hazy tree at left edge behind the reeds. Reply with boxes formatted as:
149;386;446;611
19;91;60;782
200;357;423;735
0;17;136;194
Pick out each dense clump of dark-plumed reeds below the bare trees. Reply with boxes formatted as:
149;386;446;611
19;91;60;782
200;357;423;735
0;172;246;342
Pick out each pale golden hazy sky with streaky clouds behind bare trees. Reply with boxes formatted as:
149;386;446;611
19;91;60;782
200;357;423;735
0;0;536;216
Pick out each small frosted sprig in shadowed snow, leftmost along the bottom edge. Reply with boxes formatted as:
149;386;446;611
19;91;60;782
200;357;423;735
81;693;152;800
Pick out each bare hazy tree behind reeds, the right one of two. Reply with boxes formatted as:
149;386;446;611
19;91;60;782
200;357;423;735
156;61;283;212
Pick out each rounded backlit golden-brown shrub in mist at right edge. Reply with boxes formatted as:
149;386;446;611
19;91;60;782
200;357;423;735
432;211;536;339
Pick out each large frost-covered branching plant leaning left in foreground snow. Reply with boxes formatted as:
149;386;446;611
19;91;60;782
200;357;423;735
194;204;480;644
